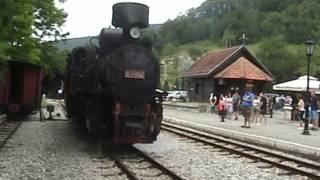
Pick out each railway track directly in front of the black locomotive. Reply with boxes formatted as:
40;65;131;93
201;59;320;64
111;146;183;180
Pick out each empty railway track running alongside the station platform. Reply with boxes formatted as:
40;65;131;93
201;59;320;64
162;122;320;179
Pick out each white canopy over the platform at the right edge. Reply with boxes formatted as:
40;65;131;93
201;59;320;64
273;75;320;94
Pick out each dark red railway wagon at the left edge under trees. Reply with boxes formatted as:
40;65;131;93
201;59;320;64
0;61;41;114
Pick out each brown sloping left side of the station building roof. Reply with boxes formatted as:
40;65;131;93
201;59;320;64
181;46;241;77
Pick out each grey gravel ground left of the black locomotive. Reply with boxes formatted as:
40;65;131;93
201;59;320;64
0;121;127;180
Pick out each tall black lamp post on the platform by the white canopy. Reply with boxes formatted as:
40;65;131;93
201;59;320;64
302;38;314;135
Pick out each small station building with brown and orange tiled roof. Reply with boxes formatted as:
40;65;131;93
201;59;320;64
180;46;273;102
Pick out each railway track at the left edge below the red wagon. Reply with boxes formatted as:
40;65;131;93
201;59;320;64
0;120;21;151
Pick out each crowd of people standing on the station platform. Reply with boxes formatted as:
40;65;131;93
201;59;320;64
209;88;320;130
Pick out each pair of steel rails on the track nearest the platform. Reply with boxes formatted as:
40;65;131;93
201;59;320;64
162;122;320;179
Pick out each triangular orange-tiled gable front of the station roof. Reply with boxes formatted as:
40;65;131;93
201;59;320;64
214;57;273;81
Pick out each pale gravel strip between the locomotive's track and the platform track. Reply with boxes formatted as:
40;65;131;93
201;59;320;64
138;131;307;180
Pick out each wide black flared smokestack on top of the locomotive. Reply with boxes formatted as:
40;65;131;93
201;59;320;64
112;3;149;29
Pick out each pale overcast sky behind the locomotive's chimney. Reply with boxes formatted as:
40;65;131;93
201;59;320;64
56;0;205;38
